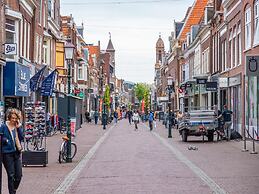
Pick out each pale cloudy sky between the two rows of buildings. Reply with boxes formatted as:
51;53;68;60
60;0;194;84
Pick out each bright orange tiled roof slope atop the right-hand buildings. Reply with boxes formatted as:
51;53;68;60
177;0;208;41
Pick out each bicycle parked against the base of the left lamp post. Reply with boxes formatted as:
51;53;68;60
58;136;77;163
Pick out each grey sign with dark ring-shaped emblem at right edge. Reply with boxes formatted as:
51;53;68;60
246;56;259;76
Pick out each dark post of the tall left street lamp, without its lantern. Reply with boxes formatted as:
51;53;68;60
66;60;72;162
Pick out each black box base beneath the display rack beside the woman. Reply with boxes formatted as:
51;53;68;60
22;151;48;167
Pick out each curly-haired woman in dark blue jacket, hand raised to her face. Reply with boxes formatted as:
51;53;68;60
0;108;23;194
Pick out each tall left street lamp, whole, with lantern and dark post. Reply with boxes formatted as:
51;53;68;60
65;42;75;162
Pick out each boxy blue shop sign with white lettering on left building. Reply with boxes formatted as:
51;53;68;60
3;62;31;96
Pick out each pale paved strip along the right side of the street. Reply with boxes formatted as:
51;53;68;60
152;130;230;194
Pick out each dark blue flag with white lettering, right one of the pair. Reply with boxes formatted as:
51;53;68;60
41;69;57;96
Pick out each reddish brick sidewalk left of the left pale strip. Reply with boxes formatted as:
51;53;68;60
2;124;106;194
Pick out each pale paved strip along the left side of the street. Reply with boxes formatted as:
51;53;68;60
54;124;115;194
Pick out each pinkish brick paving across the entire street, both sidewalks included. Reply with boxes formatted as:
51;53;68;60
3;120;259;194
